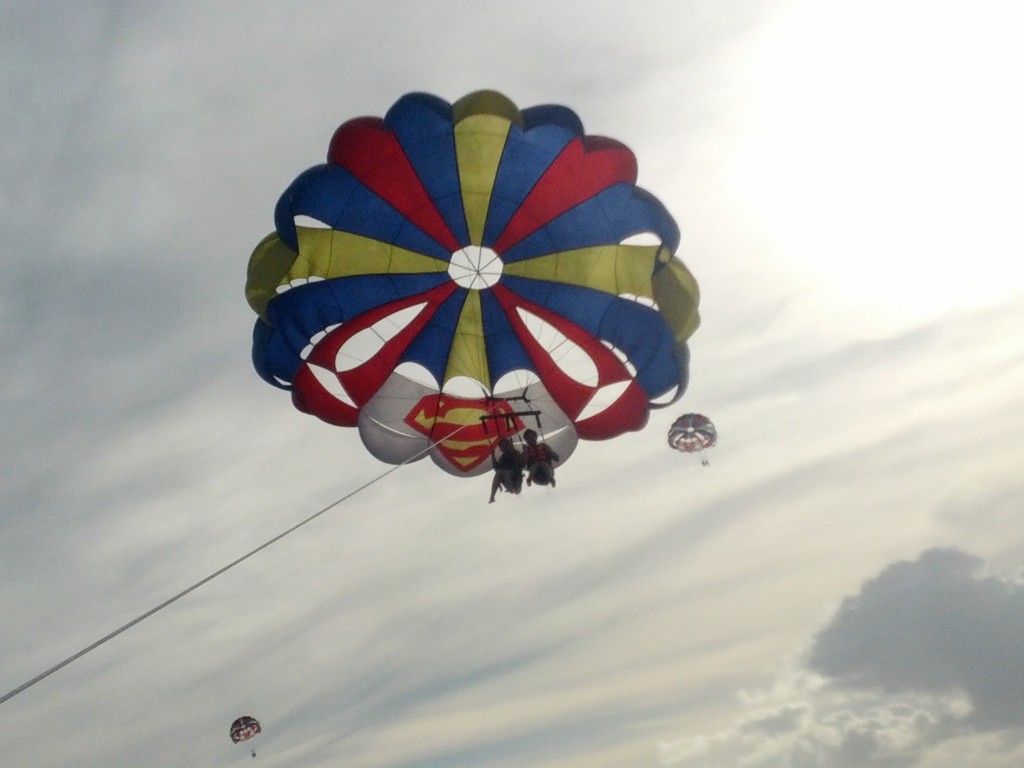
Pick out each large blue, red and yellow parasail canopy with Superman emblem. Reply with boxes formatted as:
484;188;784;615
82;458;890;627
246;91;698;476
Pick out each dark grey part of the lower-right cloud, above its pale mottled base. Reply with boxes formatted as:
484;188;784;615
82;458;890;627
807;549;1024;730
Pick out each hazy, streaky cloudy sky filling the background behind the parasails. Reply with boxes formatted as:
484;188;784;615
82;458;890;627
0;0;1024;768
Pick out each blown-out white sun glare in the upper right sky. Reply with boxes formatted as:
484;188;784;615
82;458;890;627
735;0;1024;321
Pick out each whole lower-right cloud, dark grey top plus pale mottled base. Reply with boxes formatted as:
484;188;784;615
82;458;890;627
660;549;1024;768
